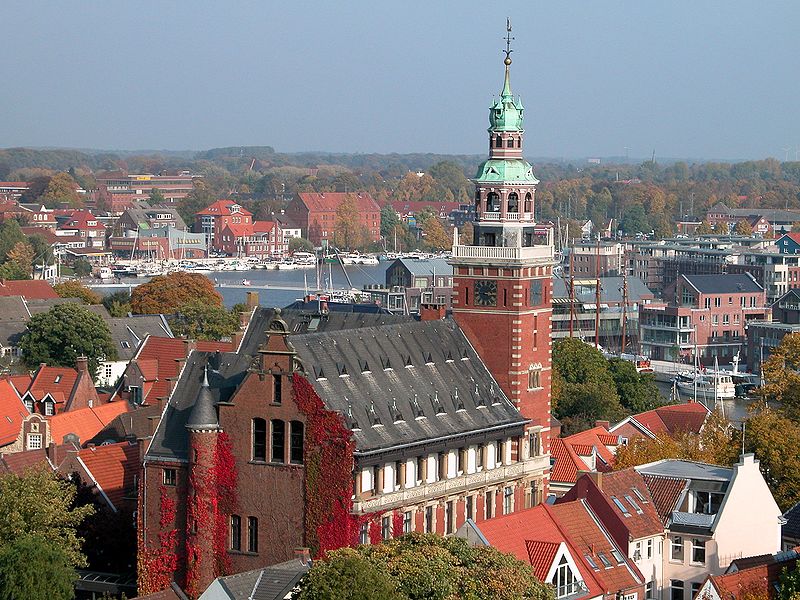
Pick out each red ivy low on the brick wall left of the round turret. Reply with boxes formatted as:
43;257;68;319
138;482;178;595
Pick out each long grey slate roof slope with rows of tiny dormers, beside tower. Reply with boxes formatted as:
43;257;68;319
292;321;527;455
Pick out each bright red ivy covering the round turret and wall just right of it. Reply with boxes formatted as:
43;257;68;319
186;432;238;598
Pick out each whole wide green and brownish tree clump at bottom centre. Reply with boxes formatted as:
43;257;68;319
295;533;554;600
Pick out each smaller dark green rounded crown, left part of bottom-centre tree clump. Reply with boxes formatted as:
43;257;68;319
293;548;408;600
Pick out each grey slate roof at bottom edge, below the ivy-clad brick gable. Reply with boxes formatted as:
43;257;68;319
211;559;310;600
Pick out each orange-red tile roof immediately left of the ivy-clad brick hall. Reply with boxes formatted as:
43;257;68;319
78;442;139;510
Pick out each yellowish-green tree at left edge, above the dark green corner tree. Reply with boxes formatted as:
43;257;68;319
0;467;94;568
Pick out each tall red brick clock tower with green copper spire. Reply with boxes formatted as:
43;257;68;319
450;24;554;478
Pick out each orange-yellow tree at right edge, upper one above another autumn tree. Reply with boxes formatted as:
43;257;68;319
760;333;800;421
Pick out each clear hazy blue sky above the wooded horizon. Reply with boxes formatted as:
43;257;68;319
0;0;800;160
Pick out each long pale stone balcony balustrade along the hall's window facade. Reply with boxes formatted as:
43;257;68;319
353;455;550;513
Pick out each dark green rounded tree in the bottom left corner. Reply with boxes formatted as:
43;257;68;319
0;534;77;600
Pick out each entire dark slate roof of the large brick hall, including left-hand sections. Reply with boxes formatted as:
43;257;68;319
148;307;526;460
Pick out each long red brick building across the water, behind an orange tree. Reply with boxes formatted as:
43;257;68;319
286;192;381;246
